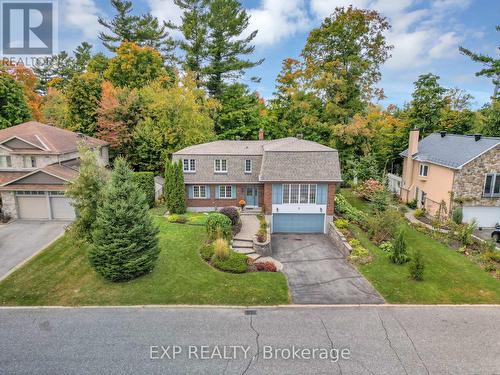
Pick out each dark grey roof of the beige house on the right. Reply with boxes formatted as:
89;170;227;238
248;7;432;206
400;133;500;169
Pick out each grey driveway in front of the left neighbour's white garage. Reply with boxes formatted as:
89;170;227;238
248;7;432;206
0;221;69;279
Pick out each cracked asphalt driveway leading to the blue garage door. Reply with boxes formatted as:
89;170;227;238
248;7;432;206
272;234;384;304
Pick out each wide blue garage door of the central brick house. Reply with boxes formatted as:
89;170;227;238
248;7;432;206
272;214;325;233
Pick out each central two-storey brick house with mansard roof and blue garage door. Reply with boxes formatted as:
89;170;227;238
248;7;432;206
173;132;341;233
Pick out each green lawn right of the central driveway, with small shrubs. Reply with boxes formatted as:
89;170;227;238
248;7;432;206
342;190;500;304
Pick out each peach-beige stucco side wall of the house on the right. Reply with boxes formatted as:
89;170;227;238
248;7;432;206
401;159;455;215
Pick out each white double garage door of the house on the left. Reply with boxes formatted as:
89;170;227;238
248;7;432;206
16;192;75;220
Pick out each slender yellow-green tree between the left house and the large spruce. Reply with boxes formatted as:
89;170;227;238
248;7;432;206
66;145;108;241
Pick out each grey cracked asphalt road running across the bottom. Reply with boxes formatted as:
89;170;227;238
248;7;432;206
0;306;500;375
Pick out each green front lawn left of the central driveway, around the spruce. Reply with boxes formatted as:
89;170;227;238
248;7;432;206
0;210;289;306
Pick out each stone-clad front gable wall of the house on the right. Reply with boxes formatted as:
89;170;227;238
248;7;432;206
453;146;500;207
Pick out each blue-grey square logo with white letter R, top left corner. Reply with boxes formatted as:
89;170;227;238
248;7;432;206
0;0;55;55
